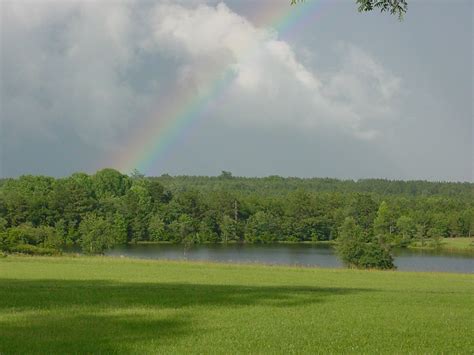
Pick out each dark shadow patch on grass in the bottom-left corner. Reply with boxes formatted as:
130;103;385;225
0;309;189;354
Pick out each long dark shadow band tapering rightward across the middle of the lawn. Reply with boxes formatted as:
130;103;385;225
0;279;365;310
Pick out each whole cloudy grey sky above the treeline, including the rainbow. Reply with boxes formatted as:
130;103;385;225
0;0;474;182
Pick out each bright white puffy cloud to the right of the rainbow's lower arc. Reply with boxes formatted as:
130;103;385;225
146;4;400;139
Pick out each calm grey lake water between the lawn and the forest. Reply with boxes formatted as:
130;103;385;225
107;244;474;273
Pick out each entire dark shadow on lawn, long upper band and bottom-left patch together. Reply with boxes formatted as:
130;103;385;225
0;279;366;353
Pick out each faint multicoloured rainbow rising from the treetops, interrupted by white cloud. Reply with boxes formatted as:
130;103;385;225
109;0;330;174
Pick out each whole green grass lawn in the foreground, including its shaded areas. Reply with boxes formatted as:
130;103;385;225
0;257;474;354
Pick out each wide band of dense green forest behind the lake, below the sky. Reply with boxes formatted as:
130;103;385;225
0;169;474;255
